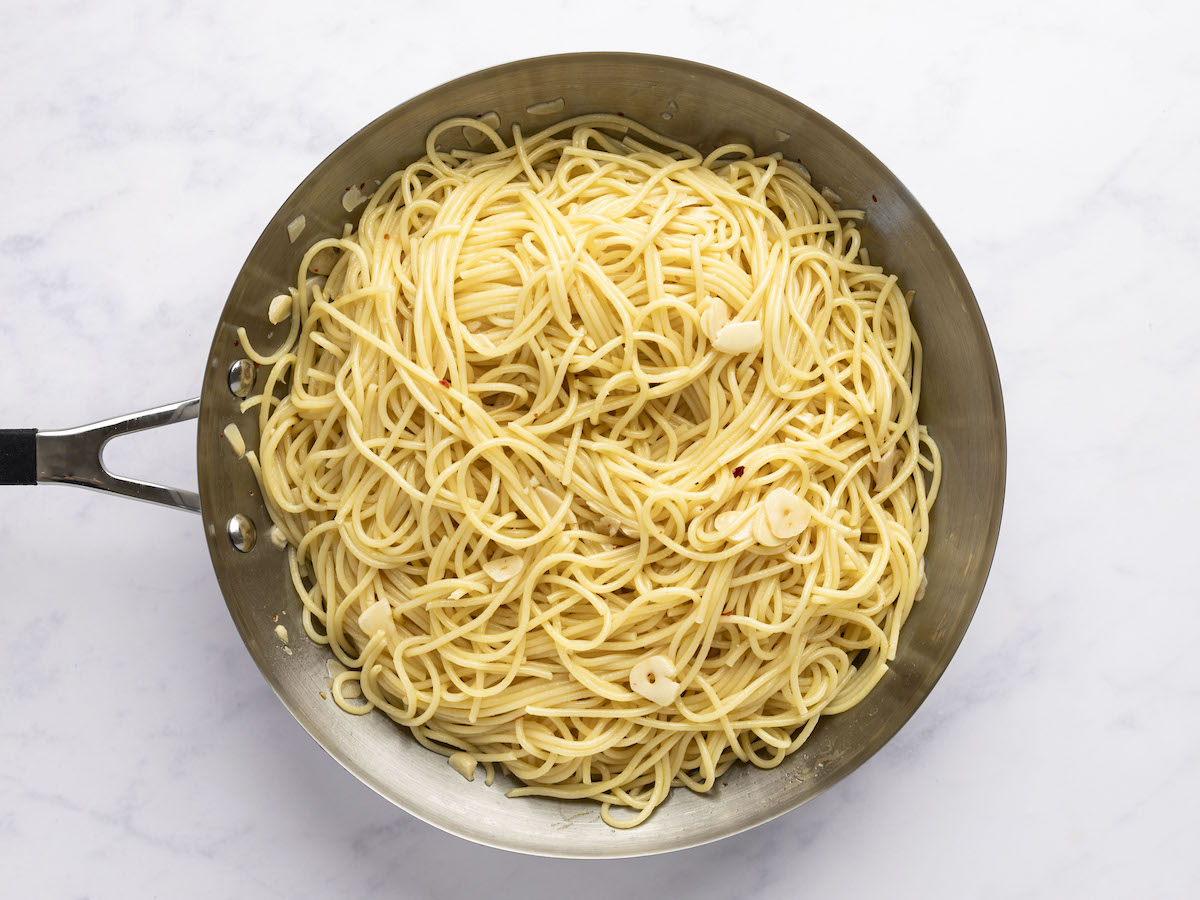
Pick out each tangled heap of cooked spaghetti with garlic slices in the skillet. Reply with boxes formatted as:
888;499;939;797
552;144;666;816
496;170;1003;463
241;115;941;827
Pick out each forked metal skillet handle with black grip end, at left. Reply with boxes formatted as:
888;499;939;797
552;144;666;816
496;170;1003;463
0;397;200;512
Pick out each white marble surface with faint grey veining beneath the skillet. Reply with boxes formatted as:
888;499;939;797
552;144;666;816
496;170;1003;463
0;0;1200;900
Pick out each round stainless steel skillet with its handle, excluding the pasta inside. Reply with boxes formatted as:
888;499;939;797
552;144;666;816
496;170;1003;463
0;53;1004;857
